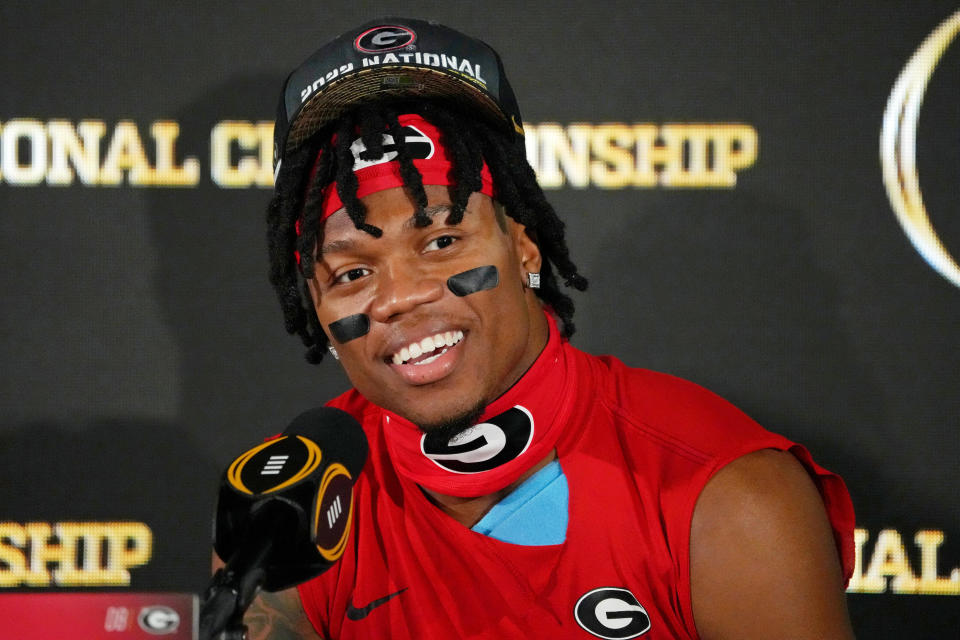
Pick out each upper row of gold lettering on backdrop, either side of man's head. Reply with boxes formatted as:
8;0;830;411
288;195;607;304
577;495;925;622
0;118;758;190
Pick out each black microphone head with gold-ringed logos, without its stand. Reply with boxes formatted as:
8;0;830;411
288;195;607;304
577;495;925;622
213;407;367;591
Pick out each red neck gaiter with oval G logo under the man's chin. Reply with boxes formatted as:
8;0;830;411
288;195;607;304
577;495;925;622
383;313;573;498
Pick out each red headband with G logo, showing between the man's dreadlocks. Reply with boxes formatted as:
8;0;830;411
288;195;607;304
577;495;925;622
310;114;494;222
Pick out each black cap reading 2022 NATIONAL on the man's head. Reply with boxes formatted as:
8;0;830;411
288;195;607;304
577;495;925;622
273;18;523;173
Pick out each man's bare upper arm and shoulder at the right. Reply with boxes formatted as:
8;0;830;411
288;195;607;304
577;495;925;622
690;450;853;640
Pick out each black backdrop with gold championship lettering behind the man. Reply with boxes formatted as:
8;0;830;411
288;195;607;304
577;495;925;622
0;0;960;638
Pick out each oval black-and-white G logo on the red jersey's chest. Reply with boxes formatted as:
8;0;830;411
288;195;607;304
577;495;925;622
573;587;650;640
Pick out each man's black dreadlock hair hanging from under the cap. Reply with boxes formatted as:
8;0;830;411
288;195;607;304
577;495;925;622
267;100;587;364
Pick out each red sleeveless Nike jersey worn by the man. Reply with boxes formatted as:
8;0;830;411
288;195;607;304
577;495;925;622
299;344;854;640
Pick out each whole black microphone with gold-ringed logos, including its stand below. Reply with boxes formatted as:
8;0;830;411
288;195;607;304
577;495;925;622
200;407;367;638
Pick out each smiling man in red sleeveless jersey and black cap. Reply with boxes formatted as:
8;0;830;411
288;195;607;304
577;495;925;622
247;18;853;640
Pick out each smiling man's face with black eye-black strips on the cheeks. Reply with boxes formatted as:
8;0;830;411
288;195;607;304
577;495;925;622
309;186;547;428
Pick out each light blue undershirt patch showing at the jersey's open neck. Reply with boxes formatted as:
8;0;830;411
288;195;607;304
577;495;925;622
473;460;569;546
